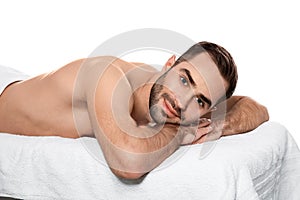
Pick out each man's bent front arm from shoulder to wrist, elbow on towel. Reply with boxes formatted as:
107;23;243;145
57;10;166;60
79;57;203;179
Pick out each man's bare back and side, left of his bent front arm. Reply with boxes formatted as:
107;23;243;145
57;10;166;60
0;57;157;138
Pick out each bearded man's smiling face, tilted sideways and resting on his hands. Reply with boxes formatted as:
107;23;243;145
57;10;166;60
149;53;227;125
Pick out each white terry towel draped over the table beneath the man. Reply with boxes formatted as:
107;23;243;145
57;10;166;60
0;122;300;200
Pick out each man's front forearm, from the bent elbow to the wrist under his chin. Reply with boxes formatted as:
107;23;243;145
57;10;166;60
108;125;182;179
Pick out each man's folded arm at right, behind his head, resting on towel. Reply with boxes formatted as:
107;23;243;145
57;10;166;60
194;96;269;143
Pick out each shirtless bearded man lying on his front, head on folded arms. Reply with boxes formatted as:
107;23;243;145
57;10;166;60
0;42;268;179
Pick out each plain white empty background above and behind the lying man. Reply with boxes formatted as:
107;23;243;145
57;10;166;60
0;0;300;147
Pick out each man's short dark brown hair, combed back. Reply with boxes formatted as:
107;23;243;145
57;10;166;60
174;41;238;100
